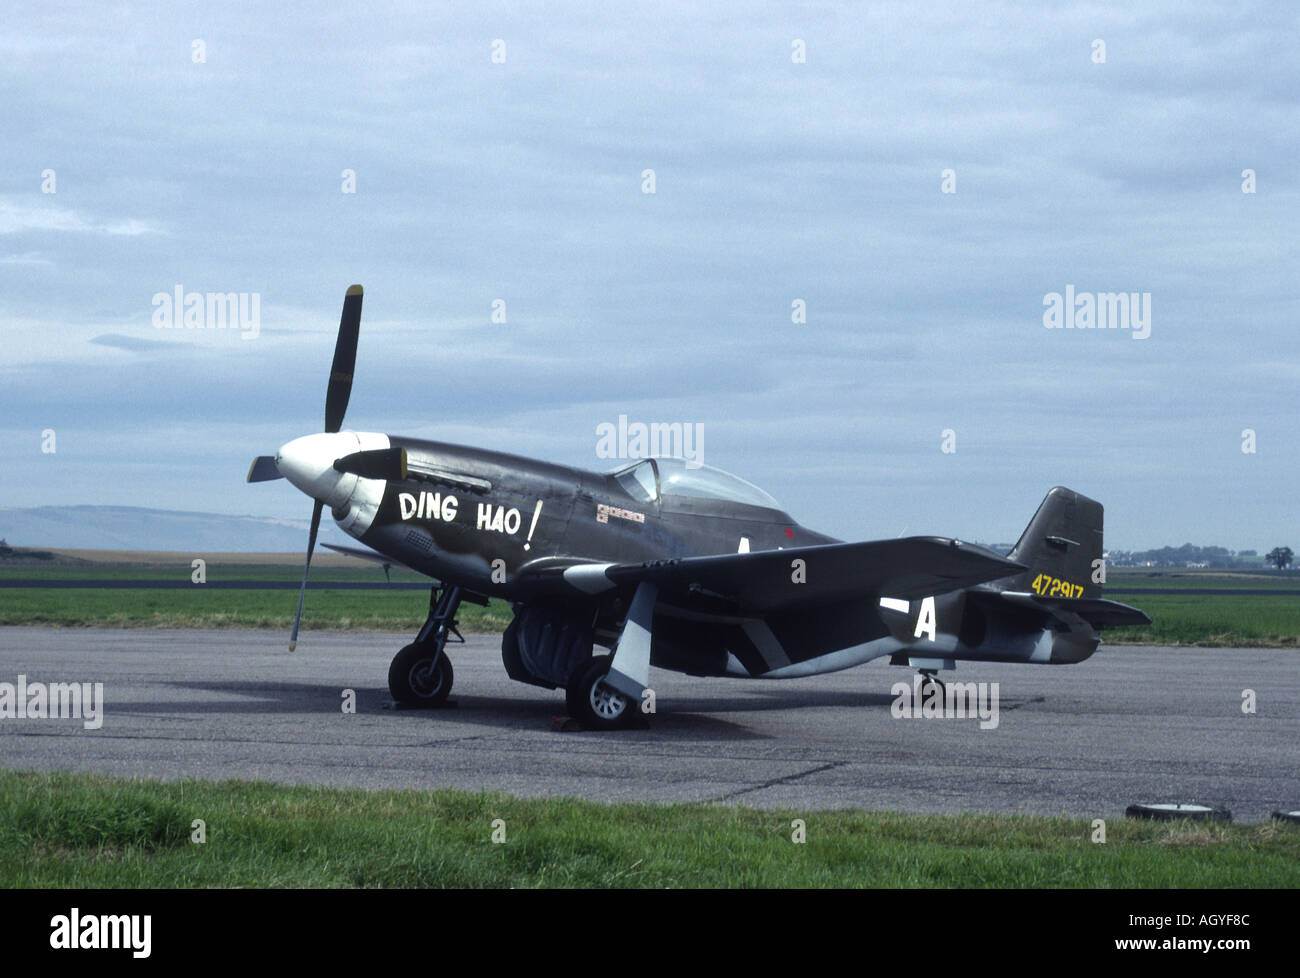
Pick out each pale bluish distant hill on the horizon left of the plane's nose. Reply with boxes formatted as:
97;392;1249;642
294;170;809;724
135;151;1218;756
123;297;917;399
0;506;330;553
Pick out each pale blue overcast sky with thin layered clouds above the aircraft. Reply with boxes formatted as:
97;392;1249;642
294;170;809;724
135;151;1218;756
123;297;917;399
0;3;1300;553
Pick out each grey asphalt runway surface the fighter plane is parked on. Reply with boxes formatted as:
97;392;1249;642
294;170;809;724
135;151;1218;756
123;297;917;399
0;627;1300;822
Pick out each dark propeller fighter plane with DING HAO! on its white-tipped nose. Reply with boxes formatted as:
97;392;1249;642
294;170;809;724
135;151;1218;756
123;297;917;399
248;285;1151;730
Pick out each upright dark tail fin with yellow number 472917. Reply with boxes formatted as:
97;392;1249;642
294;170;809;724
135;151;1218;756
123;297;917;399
1008;485;1102;598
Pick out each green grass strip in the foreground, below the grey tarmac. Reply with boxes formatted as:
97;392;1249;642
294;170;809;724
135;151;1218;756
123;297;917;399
0;773;1300;888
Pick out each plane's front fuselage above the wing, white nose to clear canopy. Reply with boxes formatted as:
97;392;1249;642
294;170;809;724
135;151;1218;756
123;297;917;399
277;432;836;600
